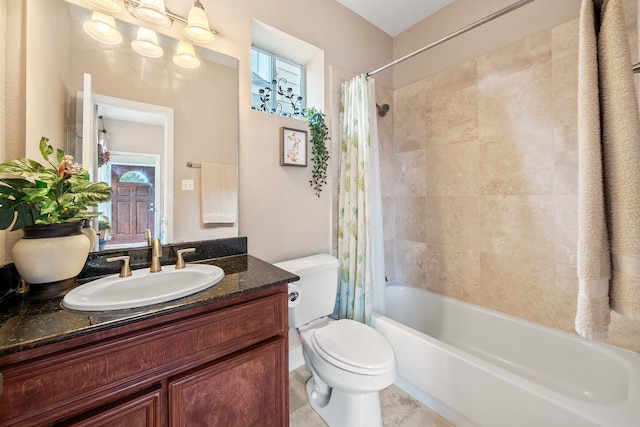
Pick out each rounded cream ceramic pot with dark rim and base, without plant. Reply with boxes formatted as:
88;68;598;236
12;223;90;299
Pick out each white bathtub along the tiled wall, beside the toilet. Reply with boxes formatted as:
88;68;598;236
371;284;640;427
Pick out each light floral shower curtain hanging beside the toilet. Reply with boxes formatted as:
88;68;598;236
337;74;385;323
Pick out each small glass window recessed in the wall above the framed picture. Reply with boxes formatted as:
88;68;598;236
251;47;305;118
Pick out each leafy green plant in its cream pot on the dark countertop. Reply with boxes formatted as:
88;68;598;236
0;137;111;299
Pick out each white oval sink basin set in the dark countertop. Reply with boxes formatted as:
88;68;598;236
62;264;224;311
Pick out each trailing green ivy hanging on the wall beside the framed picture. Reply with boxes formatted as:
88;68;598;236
304;107;329;197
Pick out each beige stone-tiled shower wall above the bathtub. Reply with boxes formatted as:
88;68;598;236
377;0;640;351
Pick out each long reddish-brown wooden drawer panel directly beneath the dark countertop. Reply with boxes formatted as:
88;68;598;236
0;294;287;426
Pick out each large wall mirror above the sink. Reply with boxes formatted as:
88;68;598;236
26;0;238;249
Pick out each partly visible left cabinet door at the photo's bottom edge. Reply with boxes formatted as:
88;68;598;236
59;389;162;427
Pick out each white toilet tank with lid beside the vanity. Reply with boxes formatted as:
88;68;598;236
274;254;339;328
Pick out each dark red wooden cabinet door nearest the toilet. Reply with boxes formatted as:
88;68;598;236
169;339;289;427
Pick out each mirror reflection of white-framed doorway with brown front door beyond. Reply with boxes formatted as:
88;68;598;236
83;93;174;249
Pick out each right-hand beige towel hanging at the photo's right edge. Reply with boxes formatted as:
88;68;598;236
598;0;640;320
